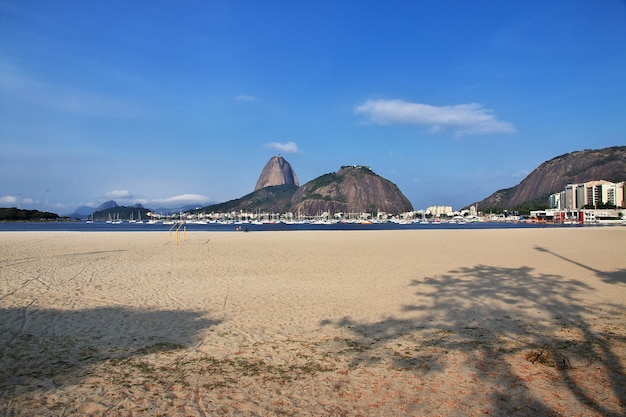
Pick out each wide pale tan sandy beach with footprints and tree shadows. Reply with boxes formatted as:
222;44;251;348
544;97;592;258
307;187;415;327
0;226;626;416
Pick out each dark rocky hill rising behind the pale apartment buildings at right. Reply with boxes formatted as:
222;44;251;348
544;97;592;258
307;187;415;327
474;146;626;211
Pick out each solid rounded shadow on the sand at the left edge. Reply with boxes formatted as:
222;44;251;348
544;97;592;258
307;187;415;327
0;307;218;400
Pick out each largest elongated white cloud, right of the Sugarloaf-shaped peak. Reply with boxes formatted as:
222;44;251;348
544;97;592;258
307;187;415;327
354;100;516;136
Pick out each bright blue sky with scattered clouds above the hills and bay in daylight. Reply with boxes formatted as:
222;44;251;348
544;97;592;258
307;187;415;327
0;0;626;214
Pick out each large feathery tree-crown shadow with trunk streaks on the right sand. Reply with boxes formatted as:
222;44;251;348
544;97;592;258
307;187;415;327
322;265;626;416
